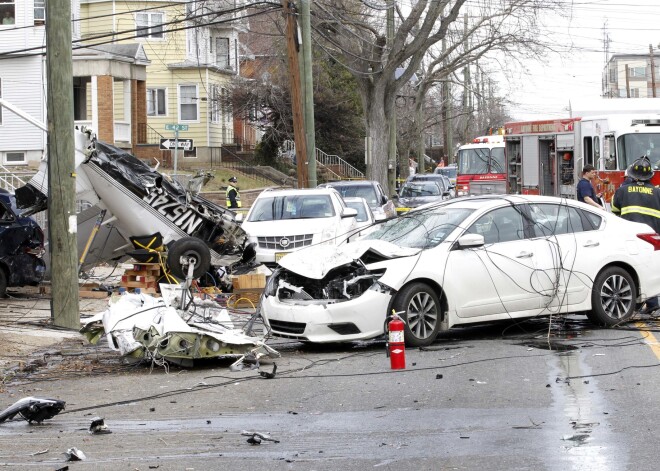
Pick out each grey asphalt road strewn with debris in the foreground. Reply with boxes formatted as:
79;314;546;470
0;298;660;471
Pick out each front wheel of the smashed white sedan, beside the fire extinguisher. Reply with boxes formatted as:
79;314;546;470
392;283;442;347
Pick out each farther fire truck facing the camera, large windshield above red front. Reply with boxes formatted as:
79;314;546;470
456;134;506;196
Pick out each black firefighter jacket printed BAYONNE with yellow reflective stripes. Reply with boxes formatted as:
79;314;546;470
612;181;660;234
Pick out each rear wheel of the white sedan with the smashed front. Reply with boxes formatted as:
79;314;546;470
587;267;637;327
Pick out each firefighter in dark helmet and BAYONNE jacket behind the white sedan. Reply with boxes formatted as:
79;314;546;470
612;156;660;314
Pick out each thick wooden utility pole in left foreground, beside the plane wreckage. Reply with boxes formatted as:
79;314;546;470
46;0;80;330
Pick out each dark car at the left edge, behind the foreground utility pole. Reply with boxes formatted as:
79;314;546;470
0;189;46;298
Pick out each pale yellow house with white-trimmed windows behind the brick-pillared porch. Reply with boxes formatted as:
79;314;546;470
80;0;240;166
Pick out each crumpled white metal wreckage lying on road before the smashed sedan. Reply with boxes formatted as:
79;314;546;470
81;283;280;370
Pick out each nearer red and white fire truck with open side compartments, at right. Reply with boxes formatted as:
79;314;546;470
504;113;660;205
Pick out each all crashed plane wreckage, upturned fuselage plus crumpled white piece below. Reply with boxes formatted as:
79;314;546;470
16;129;279;367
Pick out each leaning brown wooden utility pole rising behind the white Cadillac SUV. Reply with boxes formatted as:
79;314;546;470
282;0;309;188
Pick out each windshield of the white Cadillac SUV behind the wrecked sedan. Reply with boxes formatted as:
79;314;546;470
247;195;335;222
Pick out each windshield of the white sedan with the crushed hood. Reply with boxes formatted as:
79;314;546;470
366;207;474;249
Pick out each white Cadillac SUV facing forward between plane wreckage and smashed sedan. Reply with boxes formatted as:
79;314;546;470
242;188;357;267
